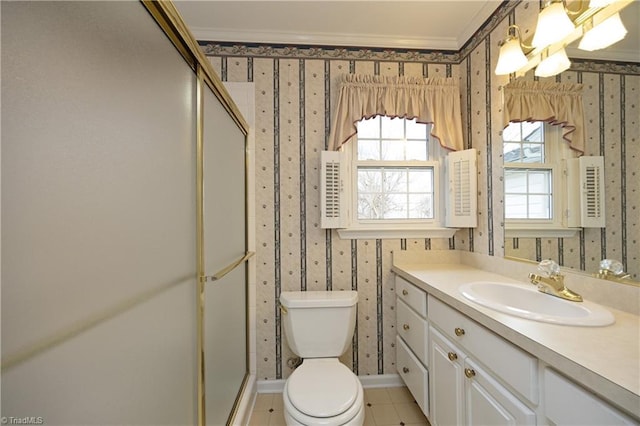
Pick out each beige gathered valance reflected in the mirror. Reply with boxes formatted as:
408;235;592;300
503;80;584;153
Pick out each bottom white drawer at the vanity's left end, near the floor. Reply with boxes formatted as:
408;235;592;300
396;336;429;417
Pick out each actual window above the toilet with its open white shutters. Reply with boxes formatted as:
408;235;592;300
322;116;477;238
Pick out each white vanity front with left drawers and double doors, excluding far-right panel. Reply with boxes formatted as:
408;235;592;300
396;276;538;426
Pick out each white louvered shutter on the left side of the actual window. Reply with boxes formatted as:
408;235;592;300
320;151;347;228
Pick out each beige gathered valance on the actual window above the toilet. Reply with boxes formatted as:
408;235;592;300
329;74;464;151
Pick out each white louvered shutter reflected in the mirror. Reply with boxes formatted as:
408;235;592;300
567;156;605;228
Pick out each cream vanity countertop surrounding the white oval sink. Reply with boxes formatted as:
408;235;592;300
392;261;640;419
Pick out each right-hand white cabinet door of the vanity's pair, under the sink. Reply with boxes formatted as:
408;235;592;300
464;358;536;426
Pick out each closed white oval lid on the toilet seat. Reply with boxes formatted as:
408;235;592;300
287;360;359;417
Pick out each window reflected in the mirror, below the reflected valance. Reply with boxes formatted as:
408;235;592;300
502;121;574;236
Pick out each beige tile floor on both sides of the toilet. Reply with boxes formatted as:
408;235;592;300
249;387;429;426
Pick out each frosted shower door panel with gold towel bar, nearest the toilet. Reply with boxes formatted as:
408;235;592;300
202;75;249;425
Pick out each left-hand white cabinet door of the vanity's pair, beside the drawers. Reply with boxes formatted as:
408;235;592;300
429;327;464;426
